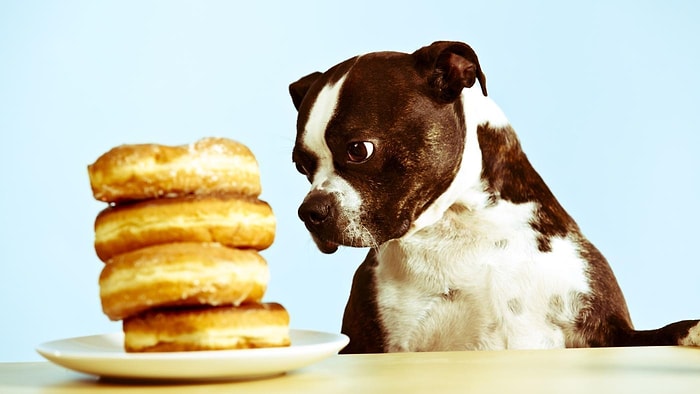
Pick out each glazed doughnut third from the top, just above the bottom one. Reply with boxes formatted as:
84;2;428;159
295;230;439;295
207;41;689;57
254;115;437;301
99;242;269;320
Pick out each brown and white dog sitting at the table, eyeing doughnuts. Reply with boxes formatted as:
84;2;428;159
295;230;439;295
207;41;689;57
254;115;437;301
289;41;700;353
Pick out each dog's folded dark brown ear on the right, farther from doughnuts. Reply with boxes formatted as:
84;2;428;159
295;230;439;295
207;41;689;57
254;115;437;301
413;41;487;102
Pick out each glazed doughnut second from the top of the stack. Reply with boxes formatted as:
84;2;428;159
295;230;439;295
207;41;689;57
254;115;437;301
95;195;275;261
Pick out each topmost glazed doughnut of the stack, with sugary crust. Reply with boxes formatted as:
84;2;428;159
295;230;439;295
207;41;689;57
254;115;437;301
88;138;261;203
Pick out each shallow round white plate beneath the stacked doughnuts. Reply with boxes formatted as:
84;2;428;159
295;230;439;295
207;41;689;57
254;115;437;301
36;330;349;380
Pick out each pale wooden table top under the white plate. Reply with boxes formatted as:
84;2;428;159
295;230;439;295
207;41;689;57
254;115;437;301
0;347;700;394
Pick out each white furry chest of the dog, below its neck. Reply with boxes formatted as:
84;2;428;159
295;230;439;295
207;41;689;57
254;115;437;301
376;202;589;351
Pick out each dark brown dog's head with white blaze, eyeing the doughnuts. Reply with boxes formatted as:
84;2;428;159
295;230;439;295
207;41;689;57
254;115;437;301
289;42;486;253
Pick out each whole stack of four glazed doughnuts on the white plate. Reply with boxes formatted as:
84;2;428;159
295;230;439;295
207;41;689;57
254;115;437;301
88;138;290;352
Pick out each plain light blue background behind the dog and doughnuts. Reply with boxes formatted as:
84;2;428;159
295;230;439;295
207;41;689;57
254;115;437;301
0;0;700;361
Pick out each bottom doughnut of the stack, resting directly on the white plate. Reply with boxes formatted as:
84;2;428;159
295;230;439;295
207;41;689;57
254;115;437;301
123;303;290;352
